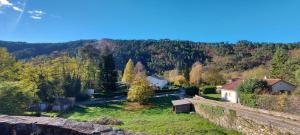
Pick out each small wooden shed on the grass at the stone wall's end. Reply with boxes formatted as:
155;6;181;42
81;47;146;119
172;99;193;113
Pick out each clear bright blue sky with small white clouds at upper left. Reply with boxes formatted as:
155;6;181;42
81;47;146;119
0;0;300;42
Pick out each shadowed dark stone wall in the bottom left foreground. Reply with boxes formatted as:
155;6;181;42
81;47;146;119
0;115;144;135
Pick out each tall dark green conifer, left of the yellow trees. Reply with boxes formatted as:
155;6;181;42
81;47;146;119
98;46;118;92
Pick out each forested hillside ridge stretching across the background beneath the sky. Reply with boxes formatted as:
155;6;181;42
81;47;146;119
0;39;300;72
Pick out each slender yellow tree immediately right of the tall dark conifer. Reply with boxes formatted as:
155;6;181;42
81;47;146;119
122;59;135;85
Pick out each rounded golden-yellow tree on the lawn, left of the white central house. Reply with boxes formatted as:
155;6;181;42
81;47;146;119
127;74;154;104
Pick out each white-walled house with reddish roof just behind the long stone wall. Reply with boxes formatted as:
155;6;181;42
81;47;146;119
221;78;242;103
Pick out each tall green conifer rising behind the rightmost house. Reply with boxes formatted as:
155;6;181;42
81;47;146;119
270;47;288;78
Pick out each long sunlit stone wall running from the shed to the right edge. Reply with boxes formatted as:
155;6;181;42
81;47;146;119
189;97;300;135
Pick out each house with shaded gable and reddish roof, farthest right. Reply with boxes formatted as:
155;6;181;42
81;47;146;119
265;78;295;94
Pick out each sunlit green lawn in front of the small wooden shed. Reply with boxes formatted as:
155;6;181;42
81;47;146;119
63;97;240;135
